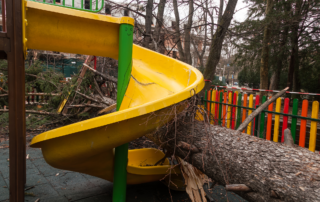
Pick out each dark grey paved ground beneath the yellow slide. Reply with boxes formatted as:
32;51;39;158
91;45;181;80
0;141;245;202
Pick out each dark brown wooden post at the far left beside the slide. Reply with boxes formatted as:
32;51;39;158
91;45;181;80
5;0;26;202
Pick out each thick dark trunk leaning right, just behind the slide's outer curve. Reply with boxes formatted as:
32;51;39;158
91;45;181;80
203;0;238;91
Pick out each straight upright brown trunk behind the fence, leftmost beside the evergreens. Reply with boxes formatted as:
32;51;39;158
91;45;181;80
260;0;273;96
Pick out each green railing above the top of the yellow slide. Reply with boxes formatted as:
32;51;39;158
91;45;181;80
29;0;104;13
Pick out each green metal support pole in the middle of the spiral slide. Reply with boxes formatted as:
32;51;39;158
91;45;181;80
112;24;133;202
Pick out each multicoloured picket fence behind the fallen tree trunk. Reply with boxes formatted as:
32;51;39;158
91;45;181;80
200;90;320;152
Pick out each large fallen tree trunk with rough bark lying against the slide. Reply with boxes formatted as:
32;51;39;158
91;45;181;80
146;104;320;202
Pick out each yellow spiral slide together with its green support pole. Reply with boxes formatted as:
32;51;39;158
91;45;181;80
23;1;204;202
